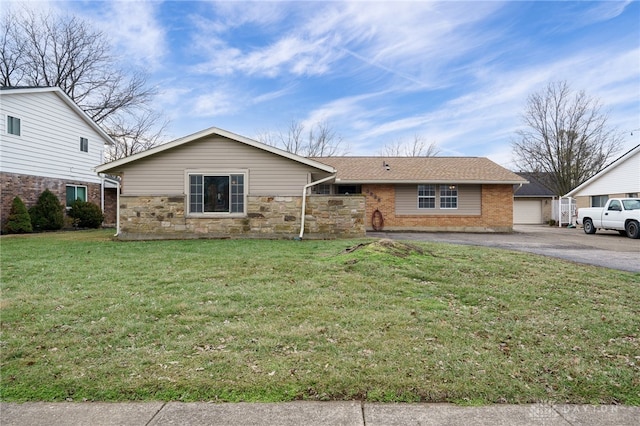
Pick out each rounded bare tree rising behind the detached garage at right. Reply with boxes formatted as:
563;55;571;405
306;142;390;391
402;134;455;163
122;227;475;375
512;81;623;196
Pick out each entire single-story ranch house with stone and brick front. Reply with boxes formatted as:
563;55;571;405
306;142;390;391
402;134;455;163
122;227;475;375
96;127;527;239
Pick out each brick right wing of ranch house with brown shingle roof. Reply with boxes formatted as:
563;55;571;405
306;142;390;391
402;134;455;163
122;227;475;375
315;157;527;232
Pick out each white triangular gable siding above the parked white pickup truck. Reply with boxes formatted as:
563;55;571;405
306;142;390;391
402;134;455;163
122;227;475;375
573;151;640;197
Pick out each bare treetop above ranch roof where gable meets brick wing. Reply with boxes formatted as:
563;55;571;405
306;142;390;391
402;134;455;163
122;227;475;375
258;120;347;157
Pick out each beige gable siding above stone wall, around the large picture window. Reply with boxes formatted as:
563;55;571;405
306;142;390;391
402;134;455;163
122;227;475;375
114;136;317;196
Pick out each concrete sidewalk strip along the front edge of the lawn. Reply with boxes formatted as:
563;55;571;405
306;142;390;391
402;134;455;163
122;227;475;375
0;401;640;426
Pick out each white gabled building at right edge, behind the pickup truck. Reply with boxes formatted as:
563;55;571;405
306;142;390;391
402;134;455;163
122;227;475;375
566;145;640;208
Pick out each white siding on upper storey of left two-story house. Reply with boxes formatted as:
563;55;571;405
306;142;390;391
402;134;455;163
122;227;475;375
0;92;106;183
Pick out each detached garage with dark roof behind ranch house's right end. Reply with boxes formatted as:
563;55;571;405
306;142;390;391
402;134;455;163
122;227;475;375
513;172;558;225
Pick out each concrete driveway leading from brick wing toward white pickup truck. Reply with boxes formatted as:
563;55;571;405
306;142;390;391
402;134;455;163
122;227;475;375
367;225;640;272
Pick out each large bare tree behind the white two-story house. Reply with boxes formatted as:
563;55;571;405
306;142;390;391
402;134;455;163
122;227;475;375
0;8;166;160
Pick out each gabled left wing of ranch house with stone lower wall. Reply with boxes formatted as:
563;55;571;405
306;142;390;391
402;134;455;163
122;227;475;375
96;128;365;239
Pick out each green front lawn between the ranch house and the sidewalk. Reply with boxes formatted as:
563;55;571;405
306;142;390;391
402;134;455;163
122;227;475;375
0;230;640;405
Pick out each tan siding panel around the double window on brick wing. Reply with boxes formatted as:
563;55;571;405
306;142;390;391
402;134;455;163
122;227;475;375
396;185;482;216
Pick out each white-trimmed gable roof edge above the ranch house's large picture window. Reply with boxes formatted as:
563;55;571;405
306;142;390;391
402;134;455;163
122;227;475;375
96;127;335;173
